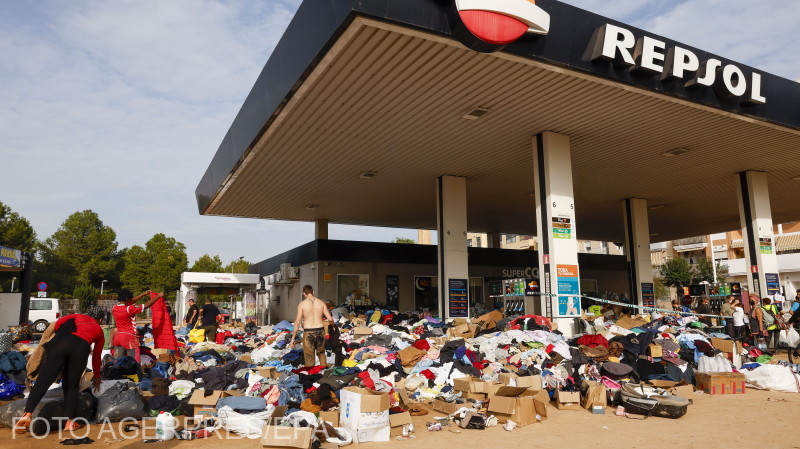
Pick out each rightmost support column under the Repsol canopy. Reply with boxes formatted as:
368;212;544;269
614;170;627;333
736;171;780;298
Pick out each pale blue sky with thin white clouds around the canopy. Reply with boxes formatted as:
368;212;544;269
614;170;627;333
0;0;800;262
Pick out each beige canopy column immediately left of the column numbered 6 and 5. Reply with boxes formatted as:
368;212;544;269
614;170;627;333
436;176;469;318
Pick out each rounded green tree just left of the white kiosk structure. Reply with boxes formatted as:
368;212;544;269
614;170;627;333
120;234;189;297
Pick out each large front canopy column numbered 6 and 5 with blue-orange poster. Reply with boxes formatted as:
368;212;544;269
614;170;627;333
533;132;581;335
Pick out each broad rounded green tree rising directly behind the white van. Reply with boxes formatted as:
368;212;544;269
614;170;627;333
38;210;119;292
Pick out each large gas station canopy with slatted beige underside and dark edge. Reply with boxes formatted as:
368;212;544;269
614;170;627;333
196;0;800;241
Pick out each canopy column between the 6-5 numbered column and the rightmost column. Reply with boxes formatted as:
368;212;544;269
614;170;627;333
622;198;656;308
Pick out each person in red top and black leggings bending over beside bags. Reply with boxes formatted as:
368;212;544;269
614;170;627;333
14;306;106;433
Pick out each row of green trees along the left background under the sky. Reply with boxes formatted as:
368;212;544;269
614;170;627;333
0;202;250;299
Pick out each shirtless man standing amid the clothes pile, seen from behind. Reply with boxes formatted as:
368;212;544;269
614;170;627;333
290;285;333;366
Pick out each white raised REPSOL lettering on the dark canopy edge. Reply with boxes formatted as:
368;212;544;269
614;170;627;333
588;24;767;104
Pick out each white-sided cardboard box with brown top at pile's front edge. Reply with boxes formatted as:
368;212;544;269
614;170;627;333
339;387;390;428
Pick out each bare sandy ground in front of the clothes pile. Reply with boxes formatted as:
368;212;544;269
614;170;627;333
0;389;800;449
